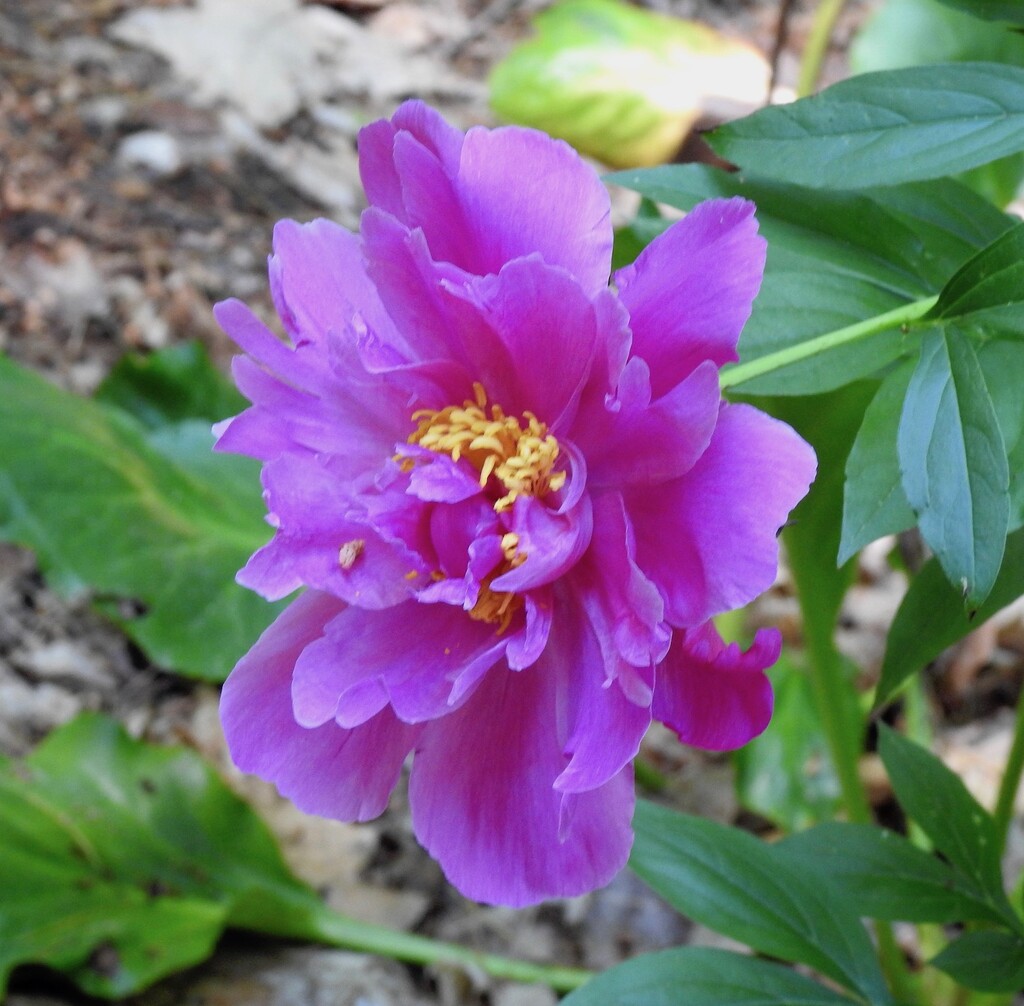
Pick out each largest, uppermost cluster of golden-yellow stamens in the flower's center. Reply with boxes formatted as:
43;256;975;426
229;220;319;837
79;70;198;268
409;383;565;513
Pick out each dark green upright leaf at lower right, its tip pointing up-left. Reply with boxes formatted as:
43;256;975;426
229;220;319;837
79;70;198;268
879;724;1015;919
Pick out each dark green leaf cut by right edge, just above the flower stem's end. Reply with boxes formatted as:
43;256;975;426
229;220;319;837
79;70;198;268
922;223;1024;336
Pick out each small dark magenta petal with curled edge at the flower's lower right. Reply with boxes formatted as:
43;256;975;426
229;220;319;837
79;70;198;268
654;622;782;751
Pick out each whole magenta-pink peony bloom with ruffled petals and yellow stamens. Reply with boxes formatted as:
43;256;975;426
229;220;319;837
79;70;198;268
217;102;815;906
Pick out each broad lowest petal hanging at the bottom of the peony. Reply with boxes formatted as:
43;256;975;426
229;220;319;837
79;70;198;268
410;667;634;908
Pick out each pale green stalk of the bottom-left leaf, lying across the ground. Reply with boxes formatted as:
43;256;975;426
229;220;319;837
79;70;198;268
294;906;594;992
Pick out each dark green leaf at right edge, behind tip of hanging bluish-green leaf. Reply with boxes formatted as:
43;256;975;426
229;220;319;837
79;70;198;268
874;531;1024;707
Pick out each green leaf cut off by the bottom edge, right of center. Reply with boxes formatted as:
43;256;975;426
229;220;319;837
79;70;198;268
562;947;853;1006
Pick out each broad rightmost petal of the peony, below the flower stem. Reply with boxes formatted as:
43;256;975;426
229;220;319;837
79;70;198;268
626;405;816;628
